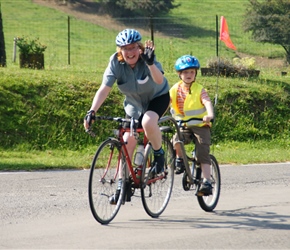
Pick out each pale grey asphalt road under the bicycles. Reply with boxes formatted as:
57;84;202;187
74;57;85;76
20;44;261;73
0;163;290;249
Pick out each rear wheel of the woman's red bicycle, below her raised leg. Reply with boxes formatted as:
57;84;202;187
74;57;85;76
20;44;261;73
141;136;174;218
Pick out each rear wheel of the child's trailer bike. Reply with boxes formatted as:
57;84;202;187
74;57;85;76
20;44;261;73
197;155;221;212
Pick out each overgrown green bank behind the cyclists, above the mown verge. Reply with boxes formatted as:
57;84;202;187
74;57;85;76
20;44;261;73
0;69;290;150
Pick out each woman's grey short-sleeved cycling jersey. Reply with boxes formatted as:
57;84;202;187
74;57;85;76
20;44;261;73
102;53;169;119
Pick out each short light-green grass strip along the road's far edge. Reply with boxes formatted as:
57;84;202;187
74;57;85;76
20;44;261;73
0;140;290;171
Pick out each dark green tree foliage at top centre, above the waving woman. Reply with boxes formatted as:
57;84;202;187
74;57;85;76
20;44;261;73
100;0;180;17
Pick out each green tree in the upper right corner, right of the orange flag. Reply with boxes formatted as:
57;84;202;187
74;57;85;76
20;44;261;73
243;0;290;64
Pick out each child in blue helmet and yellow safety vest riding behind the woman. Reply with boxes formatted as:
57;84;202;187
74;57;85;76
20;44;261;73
170;55;214;196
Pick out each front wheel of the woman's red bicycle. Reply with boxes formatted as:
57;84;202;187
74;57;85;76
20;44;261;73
89;138;126;224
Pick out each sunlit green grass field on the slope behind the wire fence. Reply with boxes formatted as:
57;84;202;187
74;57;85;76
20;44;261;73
1;0;284;71
